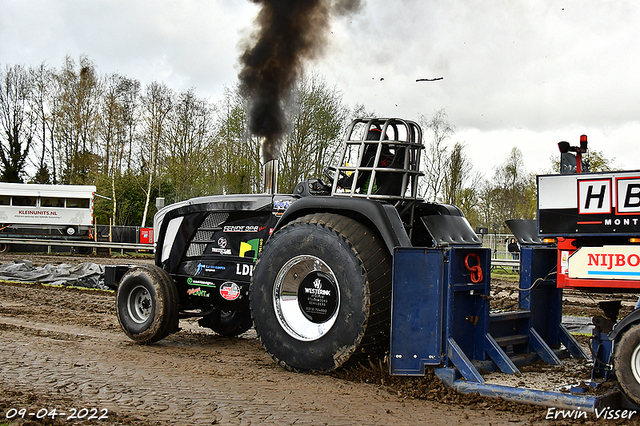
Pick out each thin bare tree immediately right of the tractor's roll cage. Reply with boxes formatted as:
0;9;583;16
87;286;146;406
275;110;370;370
420;109;455;200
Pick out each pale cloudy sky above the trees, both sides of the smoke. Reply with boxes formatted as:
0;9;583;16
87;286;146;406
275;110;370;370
0;0;640;177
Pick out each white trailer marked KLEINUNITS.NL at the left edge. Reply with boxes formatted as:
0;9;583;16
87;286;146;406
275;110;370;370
0;182;96;236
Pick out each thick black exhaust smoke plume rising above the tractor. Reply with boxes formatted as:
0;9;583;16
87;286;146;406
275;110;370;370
238;0;362;163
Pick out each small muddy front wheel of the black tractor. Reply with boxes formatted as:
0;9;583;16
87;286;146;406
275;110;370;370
116;266;178;343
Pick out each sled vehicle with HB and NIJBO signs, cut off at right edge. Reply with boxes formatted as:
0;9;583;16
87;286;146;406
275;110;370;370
538;163;640;404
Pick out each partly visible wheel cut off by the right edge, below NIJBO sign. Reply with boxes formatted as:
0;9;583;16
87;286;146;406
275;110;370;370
613;324;640;404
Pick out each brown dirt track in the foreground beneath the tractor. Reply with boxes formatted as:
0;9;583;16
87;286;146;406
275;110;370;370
0;255;632;425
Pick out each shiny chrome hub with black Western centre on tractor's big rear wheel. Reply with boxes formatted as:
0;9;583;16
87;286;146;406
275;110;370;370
273;255;340;341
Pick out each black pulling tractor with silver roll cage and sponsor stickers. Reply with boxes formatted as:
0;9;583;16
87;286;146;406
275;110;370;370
106;119;481;371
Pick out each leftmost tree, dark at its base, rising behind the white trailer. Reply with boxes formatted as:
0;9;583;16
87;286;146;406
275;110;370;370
0;65;36;183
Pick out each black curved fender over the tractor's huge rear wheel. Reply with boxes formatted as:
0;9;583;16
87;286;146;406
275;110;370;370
274;196;411;253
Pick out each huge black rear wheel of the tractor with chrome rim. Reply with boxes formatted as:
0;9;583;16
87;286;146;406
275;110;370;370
250;213;391;371
